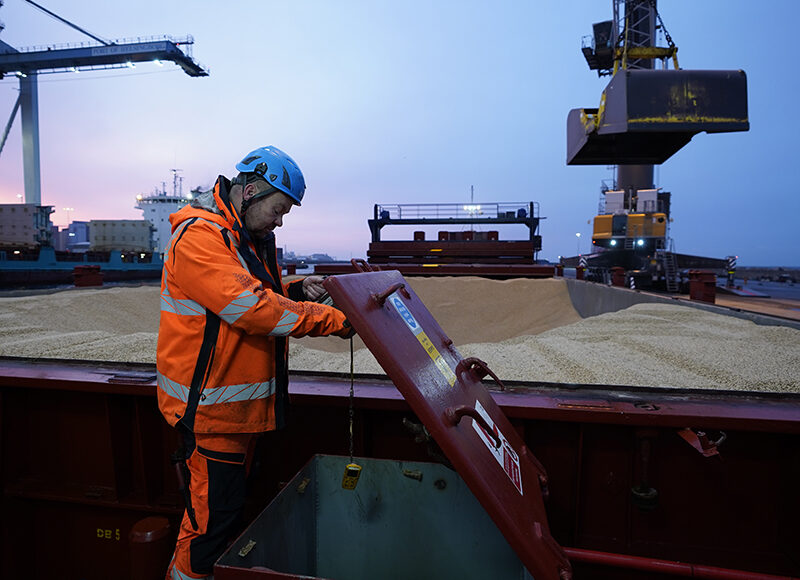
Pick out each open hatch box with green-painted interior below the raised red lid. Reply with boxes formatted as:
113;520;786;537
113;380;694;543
214;455;532;580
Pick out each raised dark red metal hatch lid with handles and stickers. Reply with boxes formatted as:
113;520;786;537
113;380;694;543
324;270;572;580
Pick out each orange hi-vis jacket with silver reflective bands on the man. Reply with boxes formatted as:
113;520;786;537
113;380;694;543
157;176;346;433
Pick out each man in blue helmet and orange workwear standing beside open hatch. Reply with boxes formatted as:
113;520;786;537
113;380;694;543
158;146;353;580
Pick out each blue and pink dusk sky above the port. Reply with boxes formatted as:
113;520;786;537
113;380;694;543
0;0;800;267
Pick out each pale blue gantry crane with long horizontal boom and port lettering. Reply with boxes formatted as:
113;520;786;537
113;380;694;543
0;0;209;206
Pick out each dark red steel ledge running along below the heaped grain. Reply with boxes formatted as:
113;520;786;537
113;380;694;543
0;358;800;433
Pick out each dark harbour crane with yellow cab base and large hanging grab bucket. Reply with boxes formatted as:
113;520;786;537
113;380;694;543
563;0;750;291
